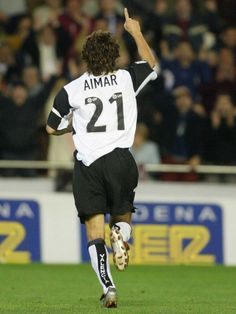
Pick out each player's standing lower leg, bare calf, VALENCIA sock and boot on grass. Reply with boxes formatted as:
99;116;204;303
85;214;117;307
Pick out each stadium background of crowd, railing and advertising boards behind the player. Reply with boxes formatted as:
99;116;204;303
0;0;236;313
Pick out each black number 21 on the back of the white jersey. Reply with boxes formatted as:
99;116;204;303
85;93;125;133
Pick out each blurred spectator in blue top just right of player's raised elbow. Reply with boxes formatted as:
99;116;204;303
161;41;211;98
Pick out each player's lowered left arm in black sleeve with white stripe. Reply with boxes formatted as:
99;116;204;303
46;88;73;135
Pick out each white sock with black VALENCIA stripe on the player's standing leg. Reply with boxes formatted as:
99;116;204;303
88;239;115;294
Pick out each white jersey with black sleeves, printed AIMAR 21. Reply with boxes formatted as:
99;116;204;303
48;61;157;166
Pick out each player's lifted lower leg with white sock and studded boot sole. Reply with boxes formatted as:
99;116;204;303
110;212;132;270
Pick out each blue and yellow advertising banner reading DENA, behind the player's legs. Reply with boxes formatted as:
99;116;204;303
81;203;224;265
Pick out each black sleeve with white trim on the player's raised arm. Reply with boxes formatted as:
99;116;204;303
127;61;159;96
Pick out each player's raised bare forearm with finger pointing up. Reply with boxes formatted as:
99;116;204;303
124;8;157;68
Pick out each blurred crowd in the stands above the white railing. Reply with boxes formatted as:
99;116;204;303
0;0;236;181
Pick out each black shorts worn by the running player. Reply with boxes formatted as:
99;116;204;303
73;148;138;223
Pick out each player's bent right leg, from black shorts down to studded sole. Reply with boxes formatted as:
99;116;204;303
104;148;138;270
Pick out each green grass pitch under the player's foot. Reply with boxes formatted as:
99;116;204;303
0;264;236;314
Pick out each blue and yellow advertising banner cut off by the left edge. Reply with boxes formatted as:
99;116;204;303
0;199;41;263
